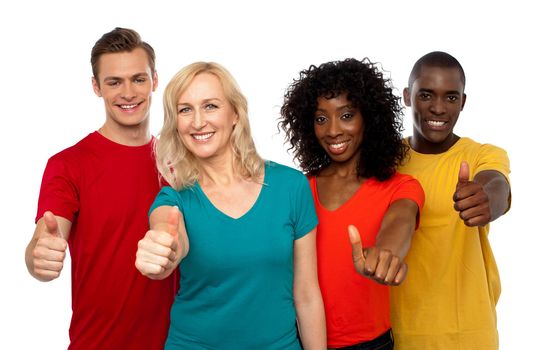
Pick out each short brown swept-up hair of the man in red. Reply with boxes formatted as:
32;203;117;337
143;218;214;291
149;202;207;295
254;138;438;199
91;27;155;80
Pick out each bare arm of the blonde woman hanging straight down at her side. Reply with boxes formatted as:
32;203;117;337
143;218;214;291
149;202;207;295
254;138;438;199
293;228;327;350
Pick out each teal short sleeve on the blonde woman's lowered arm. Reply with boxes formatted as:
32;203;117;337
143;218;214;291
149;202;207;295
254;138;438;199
291;171;317;239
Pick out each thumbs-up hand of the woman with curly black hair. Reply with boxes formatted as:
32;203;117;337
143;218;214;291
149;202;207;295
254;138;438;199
348;225;408;286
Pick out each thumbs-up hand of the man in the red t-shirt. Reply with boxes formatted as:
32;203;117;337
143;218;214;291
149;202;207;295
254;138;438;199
32;211;68;281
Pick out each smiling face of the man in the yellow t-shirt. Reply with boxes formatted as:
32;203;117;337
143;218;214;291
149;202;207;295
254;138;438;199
404;66;466;154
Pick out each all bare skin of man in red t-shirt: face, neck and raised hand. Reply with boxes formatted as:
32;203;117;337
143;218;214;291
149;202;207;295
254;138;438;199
25;48;157;281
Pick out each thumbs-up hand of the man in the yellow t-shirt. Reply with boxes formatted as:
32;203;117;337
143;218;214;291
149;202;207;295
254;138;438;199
453;161;491;226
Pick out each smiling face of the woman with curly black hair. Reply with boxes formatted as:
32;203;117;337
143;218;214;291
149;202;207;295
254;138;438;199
314;93;364;166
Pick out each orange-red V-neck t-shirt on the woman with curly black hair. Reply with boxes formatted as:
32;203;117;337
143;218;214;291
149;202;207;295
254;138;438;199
309;173;425;348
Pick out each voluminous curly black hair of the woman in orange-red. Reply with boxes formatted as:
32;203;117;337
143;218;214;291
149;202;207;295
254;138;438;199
279;58;408;181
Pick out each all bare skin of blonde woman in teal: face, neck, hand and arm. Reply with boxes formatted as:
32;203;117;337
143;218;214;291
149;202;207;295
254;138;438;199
136;73;326;349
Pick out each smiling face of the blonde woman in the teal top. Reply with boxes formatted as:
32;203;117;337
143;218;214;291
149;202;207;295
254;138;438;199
177;73;238;159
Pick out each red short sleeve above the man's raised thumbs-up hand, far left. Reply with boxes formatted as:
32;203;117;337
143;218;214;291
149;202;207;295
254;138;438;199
35;155;79;222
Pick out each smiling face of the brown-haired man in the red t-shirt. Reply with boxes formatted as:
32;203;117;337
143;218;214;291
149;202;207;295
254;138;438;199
93;48;157;129
